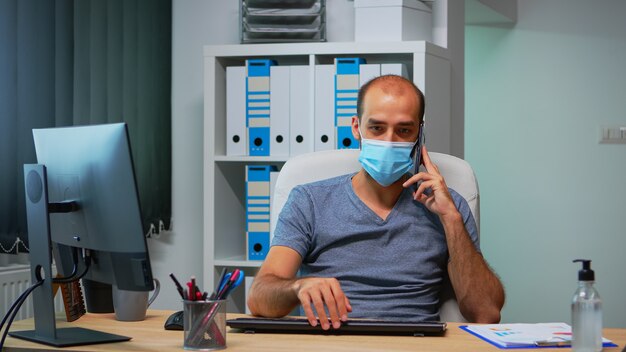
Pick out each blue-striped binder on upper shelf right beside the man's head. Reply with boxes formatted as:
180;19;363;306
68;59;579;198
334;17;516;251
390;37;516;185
335;58;365;149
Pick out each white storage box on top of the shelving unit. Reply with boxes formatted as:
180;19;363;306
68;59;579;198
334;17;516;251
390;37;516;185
354;0;432;42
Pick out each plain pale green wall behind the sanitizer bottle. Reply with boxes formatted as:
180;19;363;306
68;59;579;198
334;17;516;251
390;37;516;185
465;0;626;327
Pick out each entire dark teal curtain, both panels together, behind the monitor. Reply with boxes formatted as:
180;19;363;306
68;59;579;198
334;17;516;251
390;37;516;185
0;0;172;253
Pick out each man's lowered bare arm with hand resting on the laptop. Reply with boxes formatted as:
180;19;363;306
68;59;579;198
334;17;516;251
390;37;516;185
248;246;352;330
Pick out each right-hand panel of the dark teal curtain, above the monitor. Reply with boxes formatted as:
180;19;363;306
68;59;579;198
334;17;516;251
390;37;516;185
73;0;172;236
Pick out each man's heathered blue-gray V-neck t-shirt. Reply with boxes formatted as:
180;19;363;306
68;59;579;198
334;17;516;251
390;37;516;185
272;174;479;321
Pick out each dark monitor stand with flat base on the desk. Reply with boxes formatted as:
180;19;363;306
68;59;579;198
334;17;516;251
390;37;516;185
9;164;131;347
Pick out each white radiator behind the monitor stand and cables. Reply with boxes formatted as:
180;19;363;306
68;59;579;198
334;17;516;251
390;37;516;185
0;264;64;320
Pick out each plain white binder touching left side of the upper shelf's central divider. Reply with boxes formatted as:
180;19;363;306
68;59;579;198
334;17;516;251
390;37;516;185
289;65;314;156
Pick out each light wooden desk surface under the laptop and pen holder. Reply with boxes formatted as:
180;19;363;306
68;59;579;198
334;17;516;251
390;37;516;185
4;310;626;352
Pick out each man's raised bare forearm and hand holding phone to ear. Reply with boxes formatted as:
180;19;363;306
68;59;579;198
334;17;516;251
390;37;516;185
404;147;504;323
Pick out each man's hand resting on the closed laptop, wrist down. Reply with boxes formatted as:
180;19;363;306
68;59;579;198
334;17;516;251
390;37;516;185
293;277;352;330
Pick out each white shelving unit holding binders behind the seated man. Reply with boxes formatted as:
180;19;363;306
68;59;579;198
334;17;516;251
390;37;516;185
203;41;451;313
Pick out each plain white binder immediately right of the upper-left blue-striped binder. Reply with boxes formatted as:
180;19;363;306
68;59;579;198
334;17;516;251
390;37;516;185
270;66;291;156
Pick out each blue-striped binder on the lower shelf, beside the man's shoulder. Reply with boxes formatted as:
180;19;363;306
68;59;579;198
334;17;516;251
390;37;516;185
246;165;276;260
